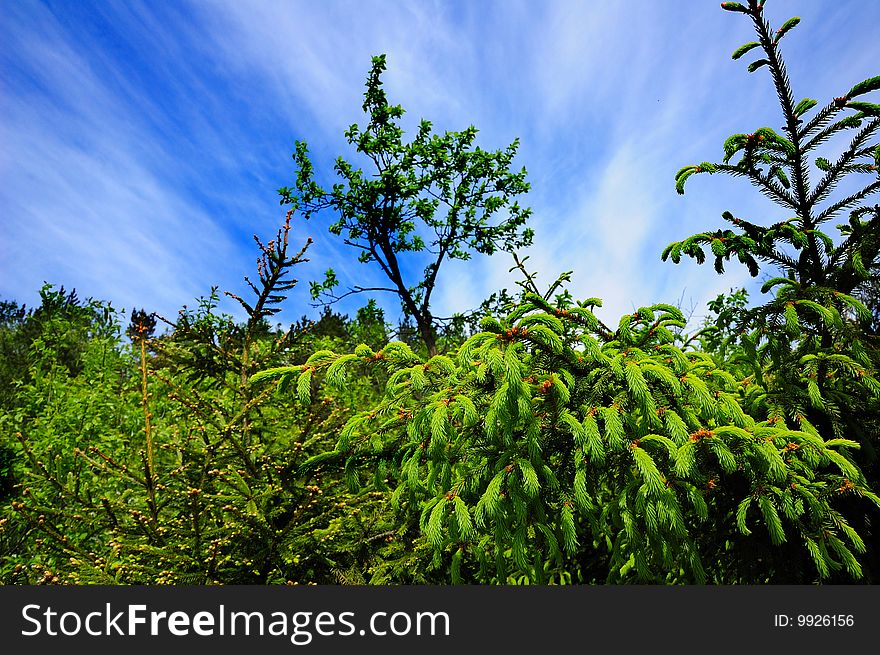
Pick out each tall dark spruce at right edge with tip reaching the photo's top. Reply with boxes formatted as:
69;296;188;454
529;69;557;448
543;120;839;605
662;0;880;577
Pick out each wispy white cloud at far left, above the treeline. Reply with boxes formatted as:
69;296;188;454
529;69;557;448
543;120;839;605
0;0;251;315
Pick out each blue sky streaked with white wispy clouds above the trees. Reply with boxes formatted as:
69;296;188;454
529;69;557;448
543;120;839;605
0;0;880;322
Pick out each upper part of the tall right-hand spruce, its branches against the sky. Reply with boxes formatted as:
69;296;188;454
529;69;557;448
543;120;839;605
663;0;880;294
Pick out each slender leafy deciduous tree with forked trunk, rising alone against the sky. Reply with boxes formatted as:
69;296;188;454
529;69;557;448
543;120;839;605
279;55;532;355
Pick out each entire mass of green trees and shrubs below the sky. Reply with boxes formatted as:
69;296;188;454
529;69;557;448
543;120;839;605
0;0;880;584
